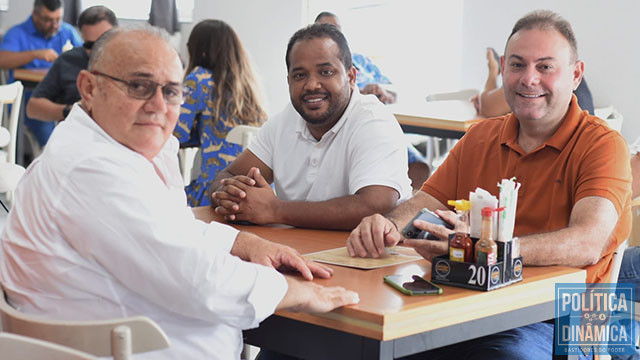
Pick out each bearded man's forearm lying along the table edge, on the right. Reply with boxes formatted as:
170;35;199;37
274;194;397;230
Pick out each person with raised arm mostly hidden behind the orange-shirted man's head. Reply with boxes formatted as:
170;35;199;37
471;48;594;117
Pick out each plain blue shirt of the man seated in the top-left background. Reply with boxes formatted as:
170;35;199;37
0;16;82;69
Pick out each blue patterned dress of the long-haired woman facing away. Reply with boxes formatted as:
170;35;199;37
173;66;242;206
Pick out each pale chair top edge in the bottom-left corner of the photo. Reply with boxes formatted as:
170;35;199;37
0;332;98;360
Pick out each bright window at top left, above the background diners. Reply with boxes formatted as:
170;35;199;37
79;0;195;22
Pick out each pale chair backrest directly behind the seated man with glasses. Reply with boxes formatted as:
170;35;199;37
0;290;169;360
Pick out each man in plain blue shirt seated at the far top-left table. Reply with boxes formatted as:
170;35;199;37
0;0;82;146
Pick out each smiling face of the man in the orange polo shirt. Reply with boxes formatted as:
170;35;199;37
502;29;584;124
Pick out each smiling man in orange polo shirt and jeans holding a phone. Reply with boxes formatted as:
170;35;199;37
347;11;631;359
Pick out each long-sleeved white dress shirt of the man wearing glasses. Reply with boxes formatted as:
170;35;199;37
0;105;287;360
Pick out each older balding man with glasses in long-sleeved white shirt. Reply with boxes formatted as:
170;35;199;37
0;26;358;359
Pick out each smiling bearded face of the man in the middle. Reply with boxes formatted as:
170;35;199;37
287;37;356;133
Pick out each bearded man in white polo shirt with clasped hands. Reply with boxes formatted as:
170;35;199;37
211;24;411;230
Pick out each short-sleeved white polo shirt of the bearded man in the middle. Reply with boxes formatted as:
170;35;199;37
248;89;411;201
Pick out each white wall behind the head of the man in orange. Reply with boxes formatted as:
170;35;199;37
462;0;640;141
